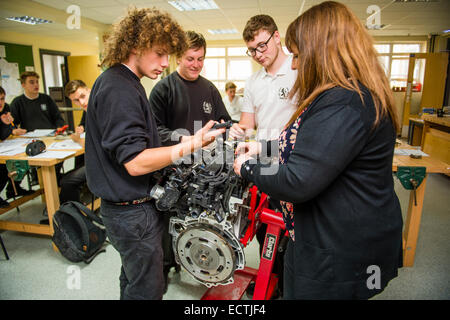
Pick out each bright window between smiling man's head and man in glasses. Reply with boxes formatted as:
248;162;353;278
201;47;253;92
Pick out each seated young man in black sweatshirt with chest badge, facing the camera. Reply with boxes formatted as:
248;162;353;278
11;71;64;131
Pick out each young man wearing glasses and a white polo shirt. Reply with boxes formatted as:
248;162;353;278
230;15;297;140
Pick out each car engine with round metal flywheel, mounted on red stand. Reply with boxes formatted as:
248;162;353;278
150;139;250;287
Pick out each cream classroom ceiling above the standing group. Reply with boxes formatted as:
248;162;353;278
5;0;450;40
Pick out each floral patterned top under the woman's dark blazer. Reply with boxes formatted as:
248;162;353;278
278;108;308;241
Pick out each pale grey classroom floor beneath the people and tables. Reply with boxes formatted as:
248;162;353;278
0;174;450;300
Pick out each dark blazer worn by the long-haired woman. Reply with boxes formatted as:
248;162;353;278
241;87;403;299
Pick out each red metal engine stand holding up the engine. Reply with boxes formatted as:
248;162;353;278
201;187;285;300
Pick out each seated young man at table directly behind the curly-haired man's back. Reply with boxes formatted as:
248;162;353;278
59;80;91;203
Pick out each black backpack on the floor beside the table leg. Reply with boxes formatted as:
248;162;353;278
52;201;106;264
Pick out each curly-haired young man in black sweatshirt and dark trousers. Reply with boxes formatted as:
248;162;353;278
85;8;224;299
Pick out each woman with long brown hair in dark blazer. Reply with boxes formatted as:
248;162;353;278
235;2;403;299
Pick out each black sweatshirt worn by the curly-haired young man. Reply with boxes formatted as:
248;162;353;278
85;64;161;202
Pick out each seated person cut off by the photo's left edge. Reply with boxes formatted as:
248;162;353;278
0;87;33;208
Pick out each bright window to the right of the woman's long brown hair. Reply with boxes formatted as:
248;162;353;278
375;42;426;91
